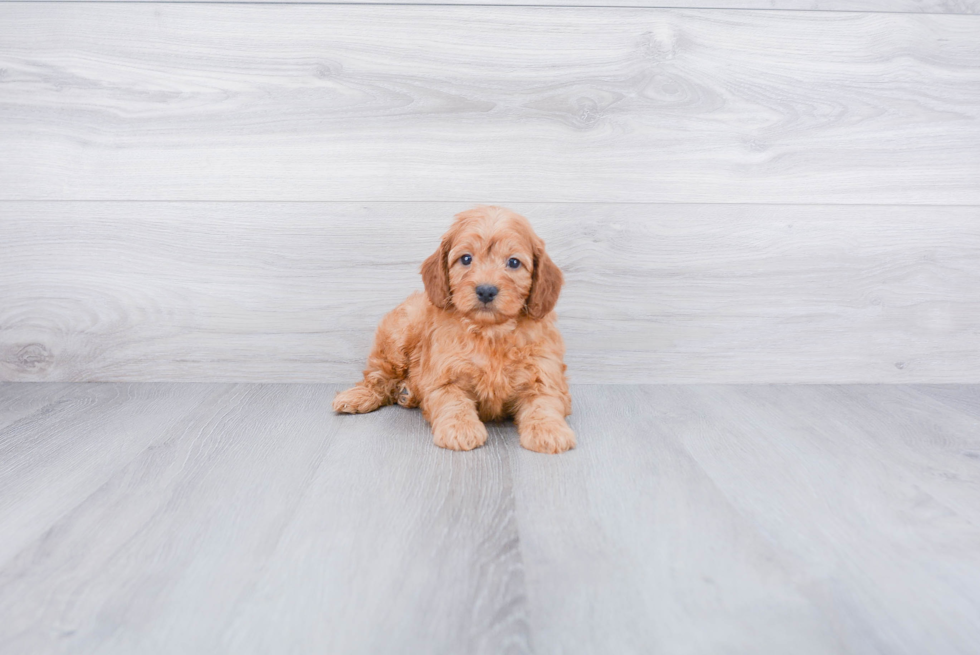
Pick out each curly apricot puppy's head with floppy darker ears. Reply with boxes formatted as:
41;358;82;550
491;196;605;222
422;207;562;325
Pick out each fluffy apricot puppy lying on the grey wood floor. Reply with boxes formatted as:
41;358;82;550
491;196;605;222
333;207;575;453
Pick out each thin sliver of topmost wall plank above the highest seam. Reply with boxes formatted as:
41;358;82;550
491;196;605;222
21;0;980;14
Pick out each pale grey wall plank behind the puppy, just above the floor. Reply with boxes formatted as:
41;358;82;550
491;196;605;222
0;202;980;383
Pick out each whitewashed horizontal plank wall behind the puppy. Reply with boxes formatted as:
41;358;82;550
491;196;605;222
0;0;980;382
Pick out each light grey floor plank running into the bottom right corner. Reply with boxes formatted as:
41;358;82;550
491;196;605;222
628;385;980;655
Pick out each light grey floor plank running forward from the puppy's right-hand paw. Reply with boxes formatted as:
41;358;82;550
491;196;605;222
504;385;844;654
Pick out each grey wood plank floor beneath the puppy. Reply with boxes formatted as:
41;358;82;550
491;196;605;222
0;383;980;654
